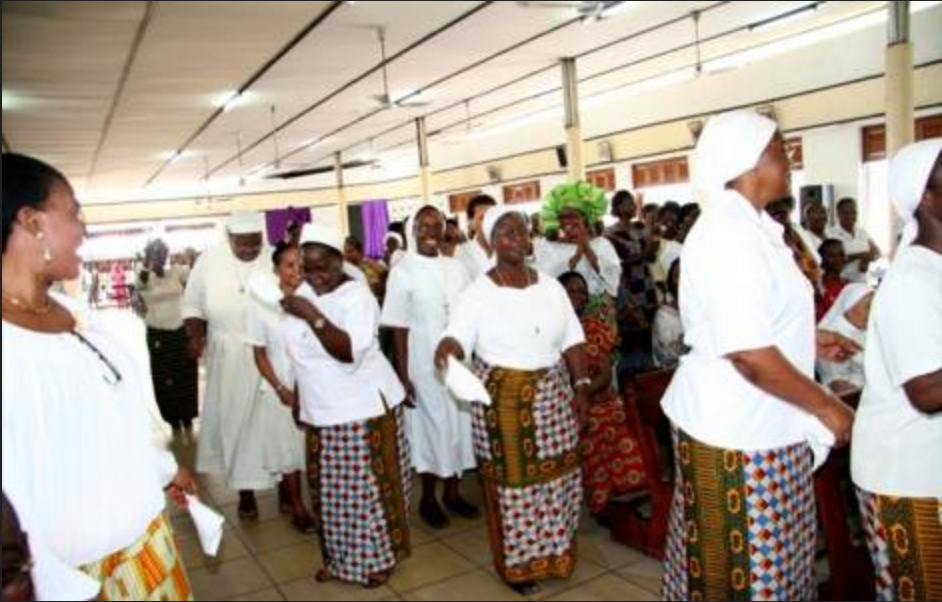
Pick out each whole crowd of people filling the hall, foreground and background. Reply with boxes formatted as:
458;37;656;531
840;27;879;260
2;111;942;600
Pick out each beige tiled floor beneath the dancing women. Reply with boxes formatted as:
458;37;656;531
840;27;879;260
171;434;661;600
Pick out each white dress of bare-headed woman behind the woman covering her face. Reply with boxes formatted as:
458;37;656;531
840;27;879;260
235;302;305;489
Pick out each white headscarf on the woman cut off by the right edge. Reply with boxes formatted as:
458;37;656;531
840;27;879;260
890;138;942;250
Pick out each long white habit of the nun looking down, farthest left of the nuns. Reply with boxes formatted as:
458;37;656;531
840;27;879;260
183;243;270;489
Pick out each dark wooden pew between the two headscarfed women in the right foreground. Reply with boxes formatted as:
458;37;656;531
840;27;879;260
814;393;875;600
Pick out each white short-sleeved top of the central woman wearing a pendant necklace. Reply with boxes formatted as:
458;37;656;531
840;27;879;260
442;272;585;370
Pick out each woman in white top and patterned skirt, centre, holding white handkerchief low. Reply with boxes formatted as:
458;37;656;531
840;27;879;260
435;207;592;593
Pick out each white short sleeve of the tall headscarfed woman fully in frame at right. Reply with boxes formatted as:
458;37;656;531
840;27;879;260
696;232;775;356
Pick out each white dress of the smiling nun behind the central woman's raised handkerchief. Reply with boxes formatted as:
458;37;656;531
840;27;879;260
381;253;475;478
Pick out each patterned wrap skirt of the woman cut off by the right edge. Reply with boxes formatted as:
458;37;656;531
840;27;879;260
857;489;942;600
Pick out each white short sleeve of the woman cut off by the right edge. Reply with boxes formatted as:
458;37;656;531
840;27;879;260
874;274;942;387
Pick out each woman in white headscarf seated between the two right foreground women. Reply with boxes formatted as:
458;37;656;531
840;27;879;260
816;284;873;395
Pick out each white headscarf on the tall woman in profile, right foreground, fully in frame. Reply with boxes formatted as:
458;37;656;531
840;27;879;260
693;110;778;199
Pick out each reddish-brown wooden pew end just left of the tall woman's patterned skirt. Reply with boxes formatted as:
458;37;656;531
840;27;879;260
609;370;674;558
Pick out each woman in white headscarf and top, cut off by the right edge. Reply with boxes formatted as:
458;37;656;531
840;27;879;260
851;138;942;600
